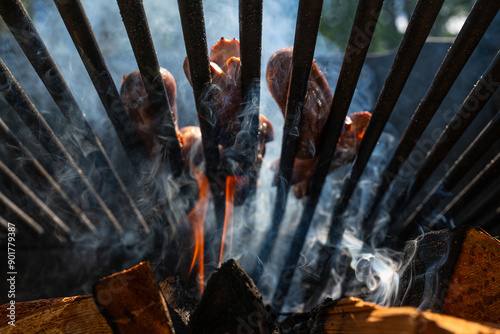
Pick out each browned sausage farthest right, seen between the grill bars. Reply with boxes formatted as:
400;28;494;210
266;47;371;198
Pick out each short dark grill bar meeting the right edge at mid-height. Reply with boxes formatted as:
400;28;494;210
428;153;500;228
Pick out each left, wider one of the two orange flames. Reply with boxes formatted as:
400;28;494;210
187;165;210;292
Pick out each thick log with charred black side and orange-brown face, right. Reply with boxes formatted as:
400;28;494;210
396;226;500;323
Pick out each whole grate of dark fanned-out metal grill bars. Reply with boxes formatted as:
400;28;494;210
0;0;500;310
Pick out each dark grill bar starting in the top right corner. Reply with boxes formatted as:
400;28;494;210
363;0;500;239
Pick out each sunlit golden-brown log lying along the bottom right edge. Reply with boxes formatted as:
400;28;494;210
311;298;500;334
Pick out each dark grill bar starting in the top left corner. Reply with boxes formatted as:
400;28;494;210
0;0;148;232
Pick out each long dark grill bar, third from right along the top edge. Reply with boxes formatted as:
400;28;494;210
273;0;384;312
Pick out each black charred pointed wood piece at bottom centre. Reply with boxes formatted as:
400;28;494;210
190;260;275;334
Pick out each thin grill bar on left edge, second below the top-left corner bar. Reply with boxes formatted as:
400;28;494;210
0;119;96;232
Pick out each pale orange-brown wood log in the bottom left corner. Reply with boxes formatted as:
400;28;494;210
0;295;112;334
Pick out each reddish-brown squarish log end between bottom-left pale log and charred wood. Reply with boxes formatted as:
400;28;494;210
93;262;175;334
